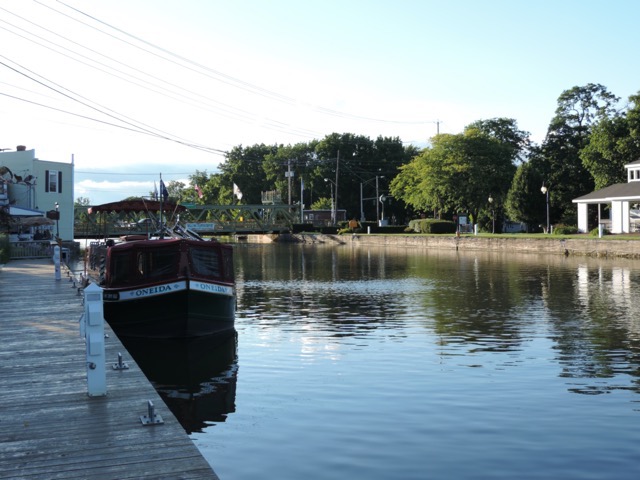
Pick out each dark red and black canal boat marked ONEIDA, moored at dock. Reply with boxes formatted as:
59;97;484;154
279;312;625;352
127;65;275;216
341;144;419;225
90;237;236;338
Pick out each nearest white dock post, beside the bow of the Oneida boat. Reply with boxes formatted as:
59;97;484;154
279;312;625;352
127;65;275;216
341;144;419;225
80;283;107;397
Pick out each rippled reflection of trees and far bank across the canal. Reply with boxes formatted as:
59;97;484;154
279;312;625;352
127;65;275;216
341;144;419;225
236;245;640;395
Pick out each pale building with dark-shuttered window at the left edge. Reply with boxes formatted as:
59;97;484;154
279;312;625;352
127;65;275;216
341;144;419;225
0;145;74;240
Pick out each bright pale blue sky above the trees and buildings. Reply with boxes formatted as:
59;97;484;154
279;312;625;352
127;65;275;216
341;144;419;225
0;0;640;203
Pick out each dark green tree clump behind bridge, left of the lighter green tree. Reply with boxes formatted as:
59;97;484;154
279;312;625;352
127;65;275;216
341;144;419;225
192;133;417;216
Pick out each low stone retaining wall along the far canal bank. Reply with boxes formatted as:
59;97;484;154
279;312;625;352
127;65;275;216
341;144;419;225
240;233;640;259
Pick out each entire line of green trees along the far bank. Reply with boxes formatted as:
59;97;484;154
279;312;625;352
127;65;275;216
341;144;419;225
100;83;640;230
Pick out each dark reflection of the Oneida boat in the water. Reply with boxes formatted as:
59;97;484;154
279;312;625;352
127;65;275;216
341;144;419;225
122;330;238;433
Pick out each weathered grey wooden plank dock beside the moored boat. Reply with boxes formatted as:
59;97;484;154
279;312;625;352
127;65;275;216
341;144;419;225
0;260;218;479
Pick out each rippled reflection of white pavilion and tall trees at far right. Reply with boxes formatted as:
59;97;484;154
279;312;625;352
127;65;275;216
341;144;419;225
549;265;640;395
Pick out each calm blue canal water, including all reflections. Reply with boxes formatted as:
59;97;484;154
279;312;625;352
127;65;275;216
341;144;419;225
130;245;640;480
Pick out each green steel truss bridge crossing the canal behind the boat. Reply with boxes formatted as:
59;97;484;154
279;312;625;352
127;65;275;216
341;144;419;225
75;204;300;238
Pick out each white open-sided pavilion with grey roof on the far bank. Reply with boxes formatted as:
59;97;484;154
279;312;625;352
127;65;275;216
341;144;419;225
573;160;640;233
